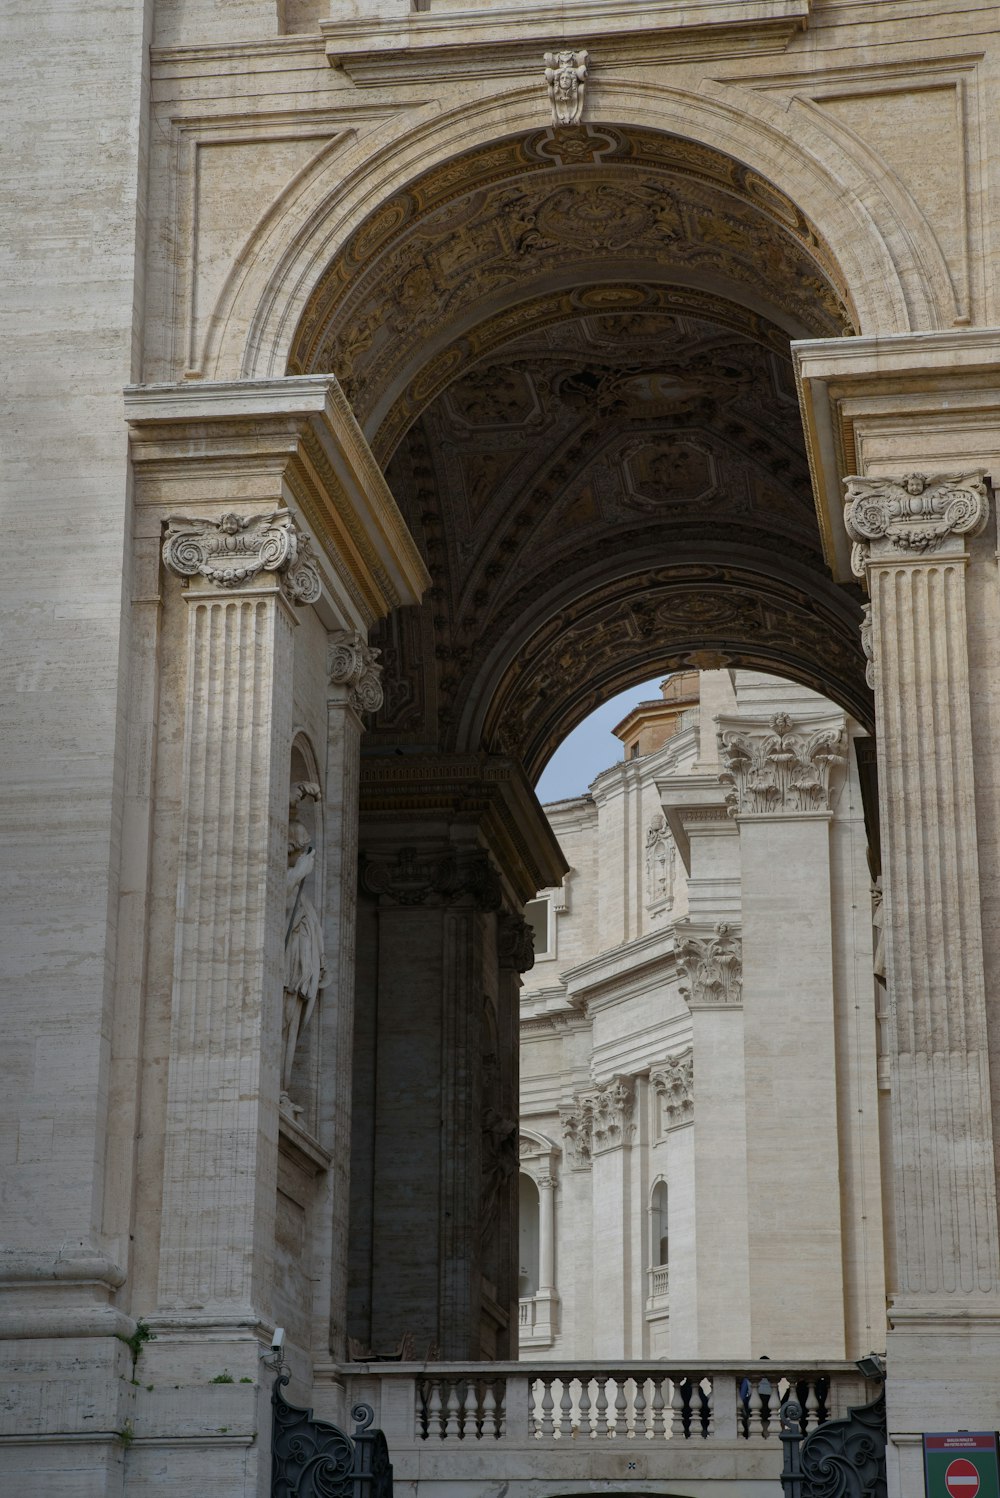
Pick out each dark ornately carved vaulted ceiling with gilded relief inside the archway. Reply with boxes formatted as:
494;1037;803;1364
292;127;870;774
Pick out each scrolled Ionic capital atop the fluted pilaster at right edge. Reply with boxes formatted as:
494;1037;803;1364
844;469;990;577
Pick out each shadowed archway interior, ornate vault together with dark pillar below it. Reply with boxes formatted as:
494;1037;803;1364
299;126;873;1357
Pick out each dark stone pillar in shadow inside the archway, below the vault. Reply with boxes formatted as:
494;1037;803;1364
349;756;564;1359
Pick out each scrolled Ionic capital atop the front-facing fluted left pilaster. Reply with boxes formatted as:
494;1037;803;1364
163;509;322;604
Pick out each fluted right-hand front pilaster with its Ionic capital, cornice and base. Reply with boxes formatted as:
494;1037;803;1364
796;330;1000;1498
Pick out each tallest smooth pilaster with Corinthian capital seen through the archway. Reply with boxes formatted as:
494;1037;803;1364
716;713;846;1357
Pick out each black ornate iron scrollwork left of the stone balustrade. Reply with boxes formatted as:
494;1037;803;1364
271;1374;392;1498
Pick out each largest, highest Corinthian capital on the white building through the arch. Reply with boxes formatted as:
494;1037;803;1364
719;713;846;816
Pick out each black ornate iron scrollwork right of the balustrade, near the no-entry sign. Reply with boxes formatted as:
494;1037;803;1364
781;1390;888;1498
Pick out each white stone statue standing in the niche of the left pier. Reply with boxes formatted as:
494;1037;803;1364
280;780;326;1115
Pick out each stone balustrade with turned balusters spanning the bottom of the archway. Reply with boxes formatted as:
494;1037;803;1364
344;1362;874;1492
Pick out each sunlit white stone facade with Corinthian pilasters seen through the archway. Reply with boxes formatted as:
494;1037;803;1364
521;671;888;1360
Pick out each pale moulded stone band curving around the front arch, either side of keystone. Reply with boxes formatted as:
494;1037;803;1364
205;79;948;379
